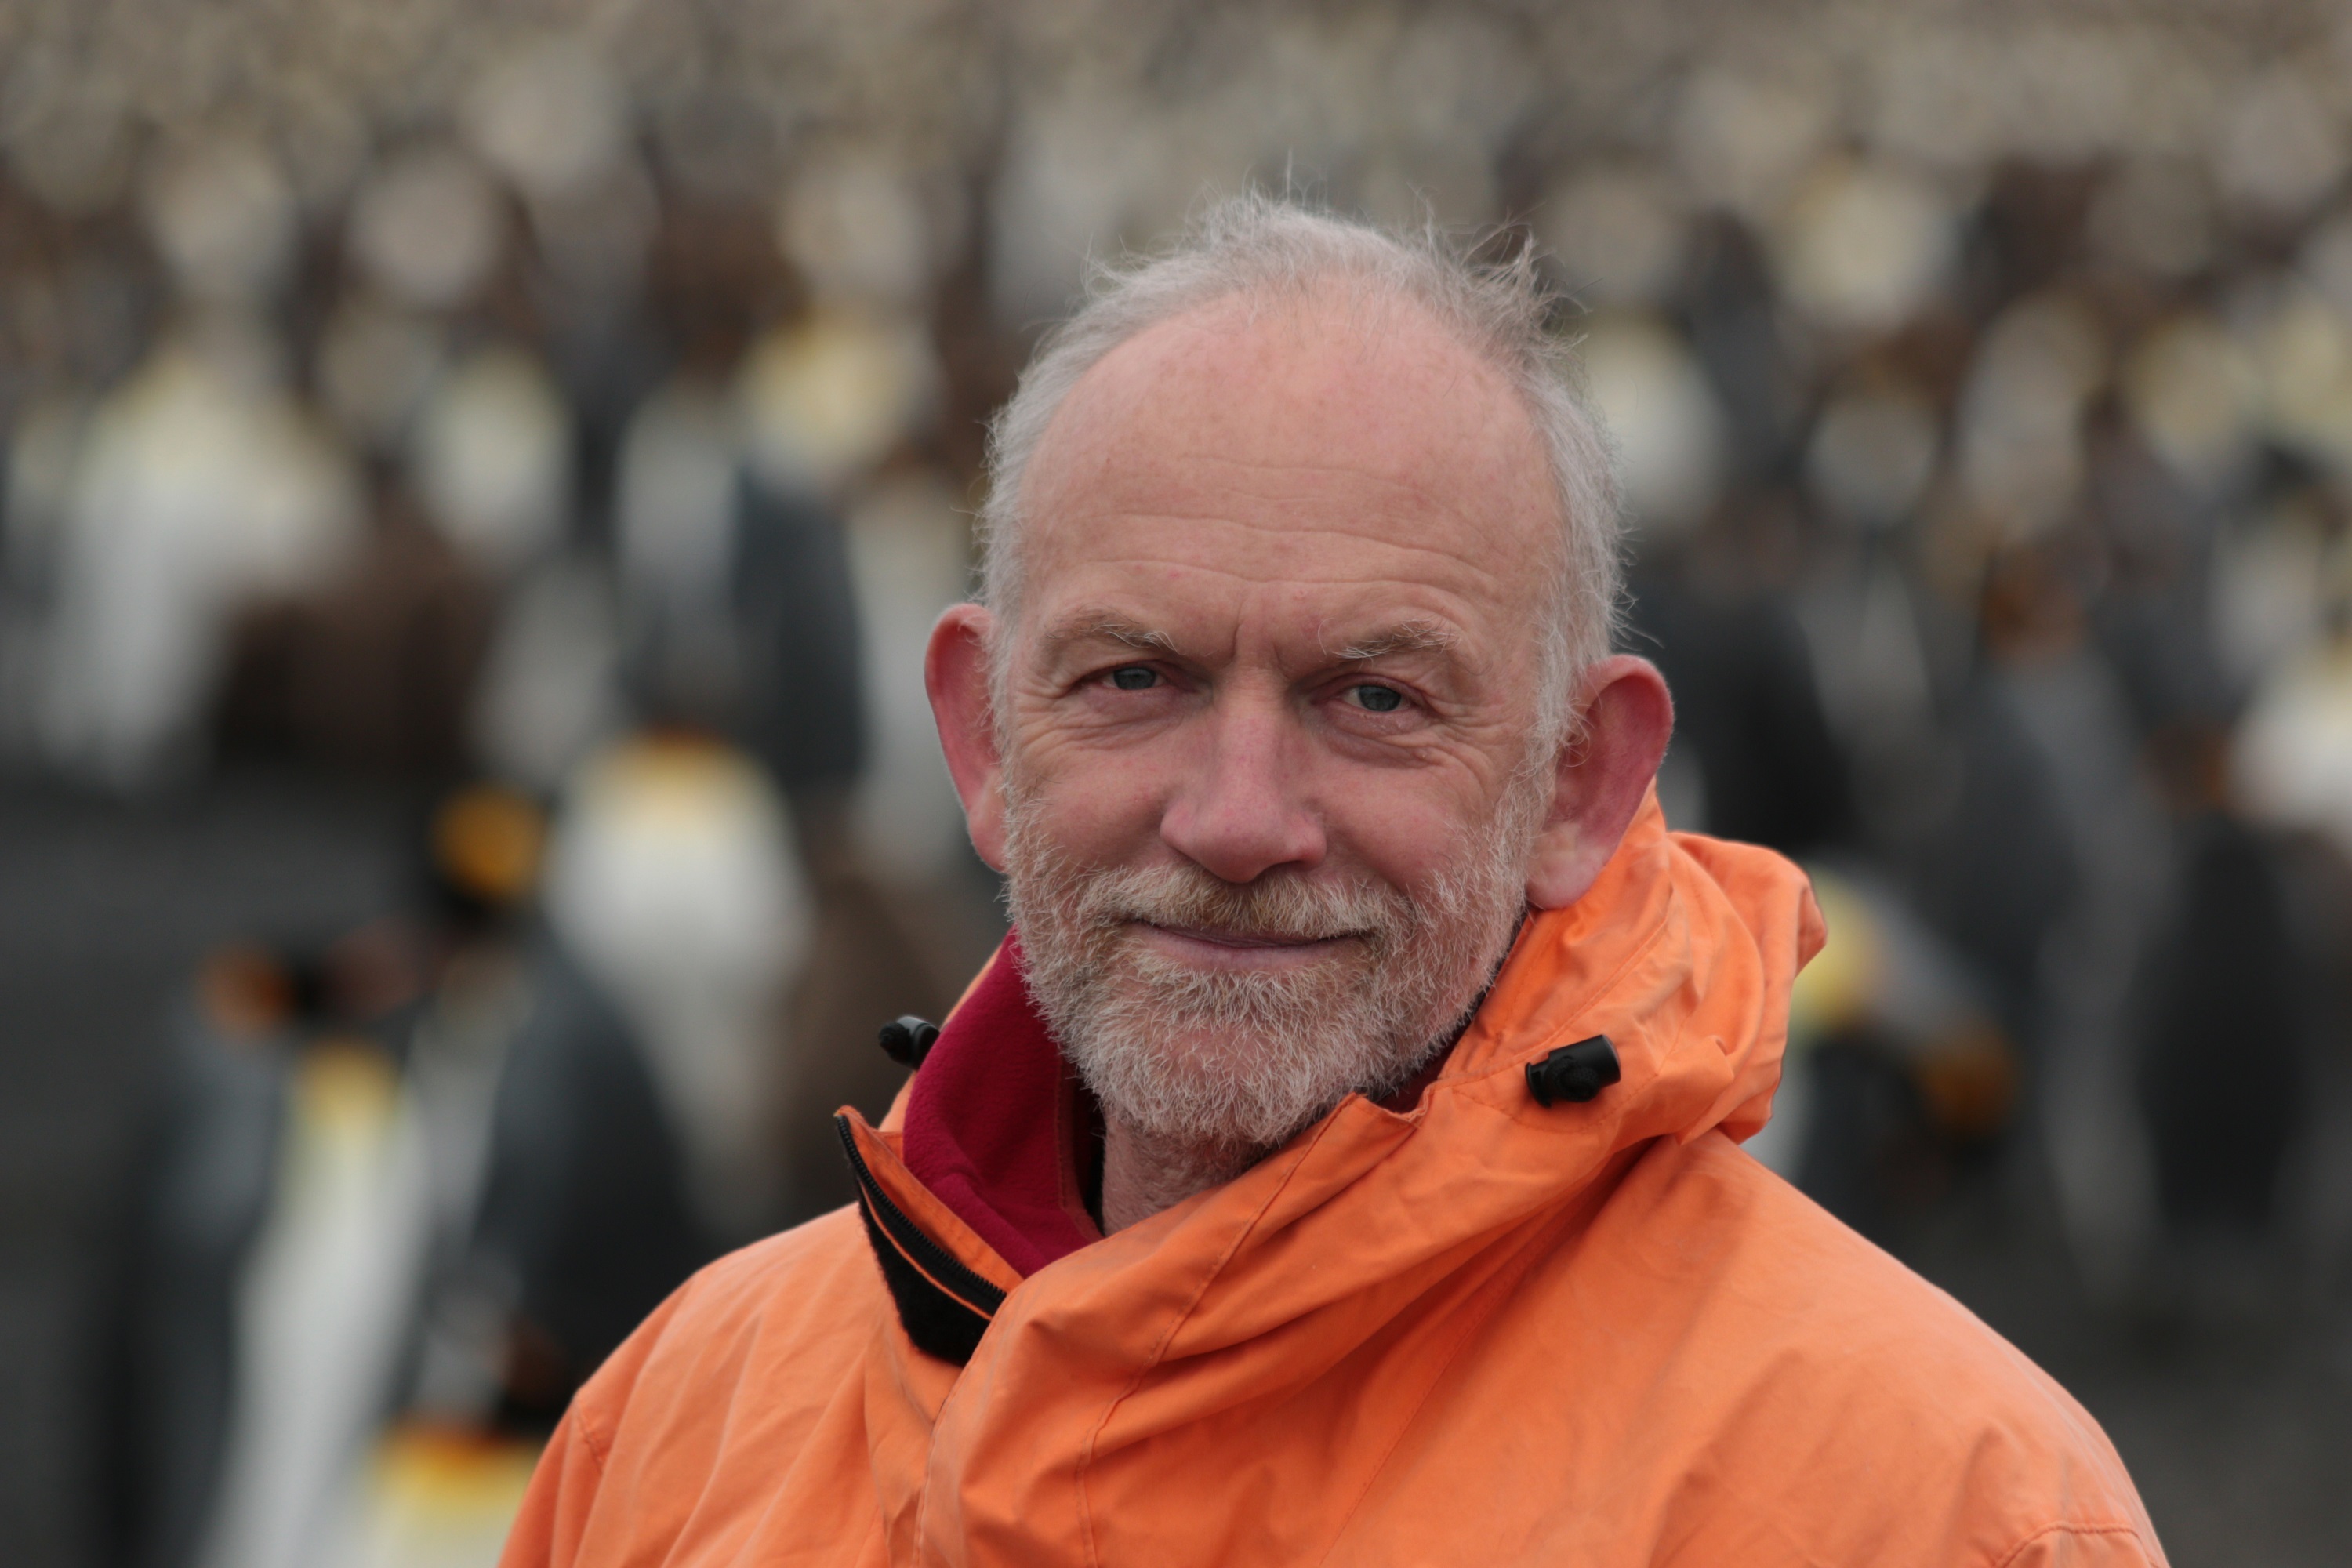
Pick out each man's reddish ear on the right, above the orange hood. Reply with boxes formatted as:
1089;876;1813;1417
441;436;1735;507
1526;654;1675;909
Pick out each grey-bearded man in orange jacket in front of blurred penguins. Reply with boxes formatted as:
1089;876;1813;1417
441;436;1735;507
506;200;2161;1568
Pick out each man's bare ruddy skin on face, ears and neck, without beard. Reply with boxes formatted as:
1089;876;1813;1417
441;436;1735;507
927;287;1672;1229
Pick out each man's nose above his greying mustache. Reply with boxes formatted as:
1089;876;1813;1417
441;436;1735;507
1160;694;1324;884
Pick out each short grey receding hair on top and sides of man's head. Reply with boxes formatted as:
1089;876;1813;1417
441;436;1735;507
981;193;1623;741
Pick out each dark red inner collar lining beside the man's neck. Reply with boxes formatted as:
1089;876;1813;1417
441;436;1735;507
898;933;1103;1274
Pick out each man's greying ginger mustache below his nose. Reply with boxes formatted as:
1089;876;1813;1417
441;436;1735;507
1075;865;1418;942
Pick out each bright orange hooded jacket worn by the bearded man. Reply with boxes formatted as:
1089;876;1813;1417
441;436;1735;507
506;806;2164;1568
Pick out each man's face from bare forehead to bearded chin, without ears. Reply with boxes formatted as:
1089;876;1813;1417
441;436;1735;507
995;292;1559;1145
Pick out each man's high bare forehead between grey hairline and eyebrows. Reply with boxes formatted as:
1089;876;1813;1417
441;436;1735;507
1021;287;1559;630
